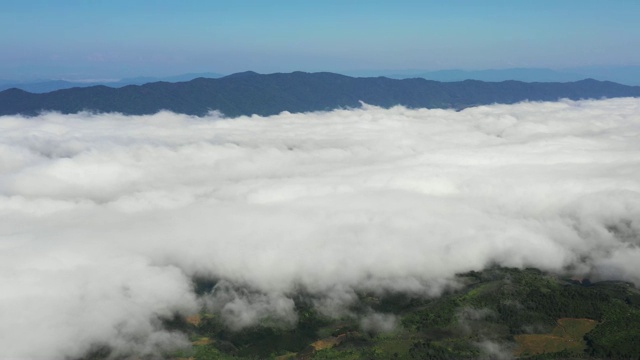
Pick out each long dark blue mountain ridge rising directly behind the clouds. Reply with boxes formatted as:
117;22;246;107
0;72;640;116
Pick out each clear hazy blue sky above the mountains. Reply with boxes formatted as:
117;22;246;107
0;0;640;79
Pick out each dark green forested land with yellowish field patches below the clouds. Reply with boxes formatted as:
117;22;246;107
79;268;640;360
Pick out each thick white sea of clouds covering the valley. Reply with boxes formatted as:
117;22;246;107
0;98;640;359
